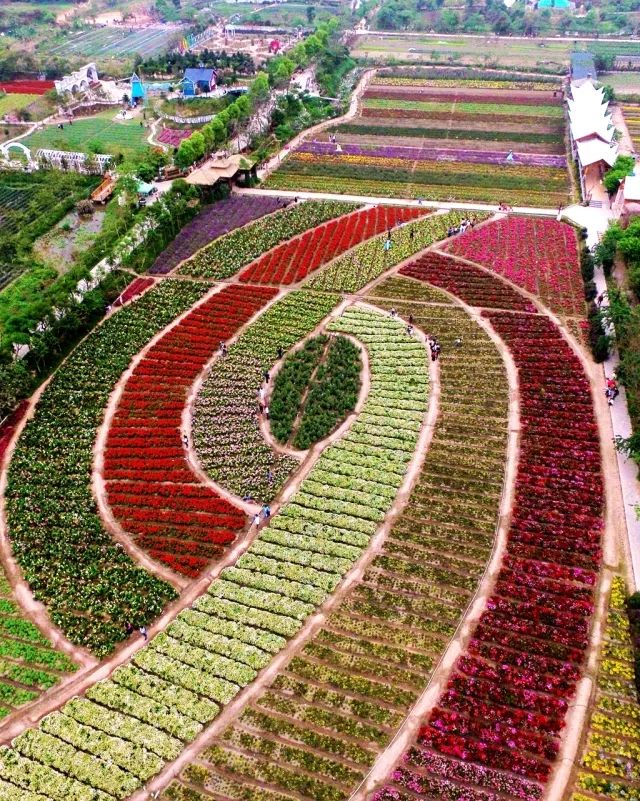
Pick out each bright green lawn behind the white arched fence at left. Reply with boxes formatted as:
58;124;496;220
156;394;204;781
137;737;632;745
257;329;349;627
22;110;149;158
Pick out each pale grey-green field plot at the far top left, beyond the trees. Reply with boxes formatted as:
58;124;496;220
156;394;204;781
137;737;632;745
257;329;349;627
48;25;180;58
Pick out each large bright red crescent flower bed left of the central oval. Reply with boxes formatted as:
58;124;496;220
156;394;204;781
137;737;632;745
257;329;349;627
104;285;277;576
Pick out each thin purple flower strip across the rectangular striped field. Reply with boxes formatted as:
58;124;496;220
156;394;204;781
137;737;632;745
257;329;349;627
296;141;567;168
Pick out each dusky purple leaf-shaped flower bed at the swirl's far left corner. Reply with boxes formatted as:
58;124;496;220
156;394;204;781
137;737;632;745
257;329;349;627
149;195;287;275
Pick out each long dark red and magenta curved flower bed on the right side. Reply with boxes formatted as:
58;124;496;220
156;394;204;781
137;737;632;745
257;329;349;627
373;273;603;801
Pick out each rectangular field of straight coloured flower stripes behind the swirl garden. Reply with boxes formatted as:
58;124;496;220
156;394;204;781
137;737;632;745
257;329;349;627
267;77;572;206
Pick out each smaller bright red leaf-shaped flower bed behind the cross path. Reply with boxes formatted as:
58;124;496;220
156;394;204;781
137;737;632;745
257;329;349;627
240;206;429;284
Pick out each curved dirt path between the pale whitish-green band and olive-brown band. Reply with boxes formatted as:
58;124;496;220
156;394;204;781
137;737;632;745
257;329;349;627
129;300;440;801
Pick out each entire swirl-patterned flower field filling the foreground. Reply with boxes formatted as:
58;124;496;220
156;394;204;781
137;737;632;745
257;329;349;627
0;197;640;801
